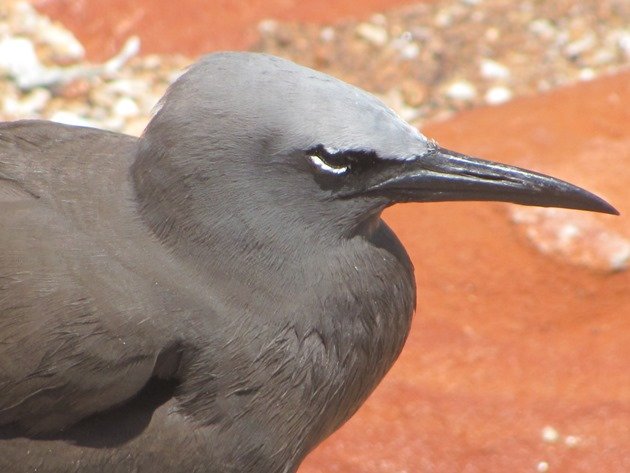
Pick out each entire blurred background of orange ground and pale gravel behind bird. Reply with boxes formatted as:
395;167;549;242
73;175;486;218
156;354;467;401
0;0;630;473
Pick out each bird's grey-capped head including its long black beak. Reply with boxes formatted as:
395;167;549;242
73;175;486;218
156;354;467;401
136;53;616;247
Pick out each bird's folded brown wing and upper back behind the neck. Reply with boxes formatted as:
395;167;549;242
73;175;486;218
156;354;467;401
0;122;180;433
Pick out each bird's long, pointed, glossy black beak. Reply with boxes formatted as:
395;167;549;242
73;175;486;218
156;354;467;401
368;146;619;215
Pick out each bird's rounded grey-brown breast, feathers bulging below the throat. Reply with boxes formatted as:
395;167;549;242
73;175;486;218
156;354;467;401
168;220;415;464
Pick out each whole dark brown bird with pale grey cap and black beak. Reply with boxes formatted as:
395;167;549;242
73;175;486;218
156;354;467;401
0;52;617;473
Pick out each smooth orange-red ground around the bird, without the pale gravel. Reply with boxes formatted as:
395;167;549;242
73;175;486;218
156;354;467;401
30;0;630;473
